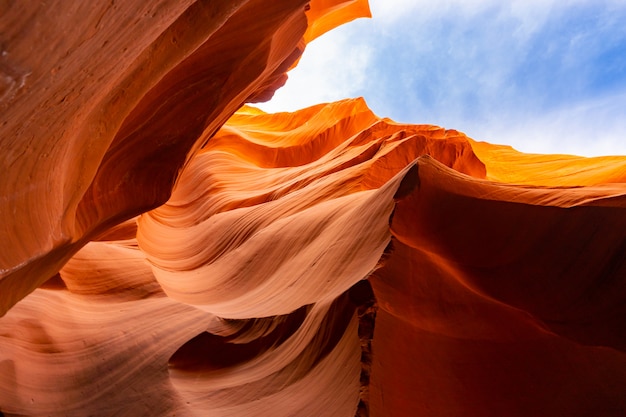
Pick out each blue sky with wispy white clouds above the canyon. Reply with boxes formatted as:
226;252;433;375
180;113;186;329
260;0;626;156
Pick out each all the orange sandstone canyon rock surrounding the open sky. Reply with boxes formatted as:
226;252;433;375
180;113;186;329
0;0;626;417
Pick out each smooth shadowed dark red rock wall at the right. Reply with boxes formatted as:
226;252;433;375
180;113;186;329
369;156;626;417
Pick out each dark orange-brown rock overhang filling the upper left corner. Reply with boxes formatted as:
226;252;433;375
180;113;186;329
0;0;369;315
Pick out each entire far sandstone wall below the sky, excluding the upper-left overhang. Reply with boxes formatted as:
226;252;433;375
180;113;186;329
0;92;626;416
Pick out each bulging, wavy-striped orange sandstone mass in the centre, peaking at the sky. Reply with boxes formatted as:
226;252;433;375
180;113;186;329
137;99;483;318
